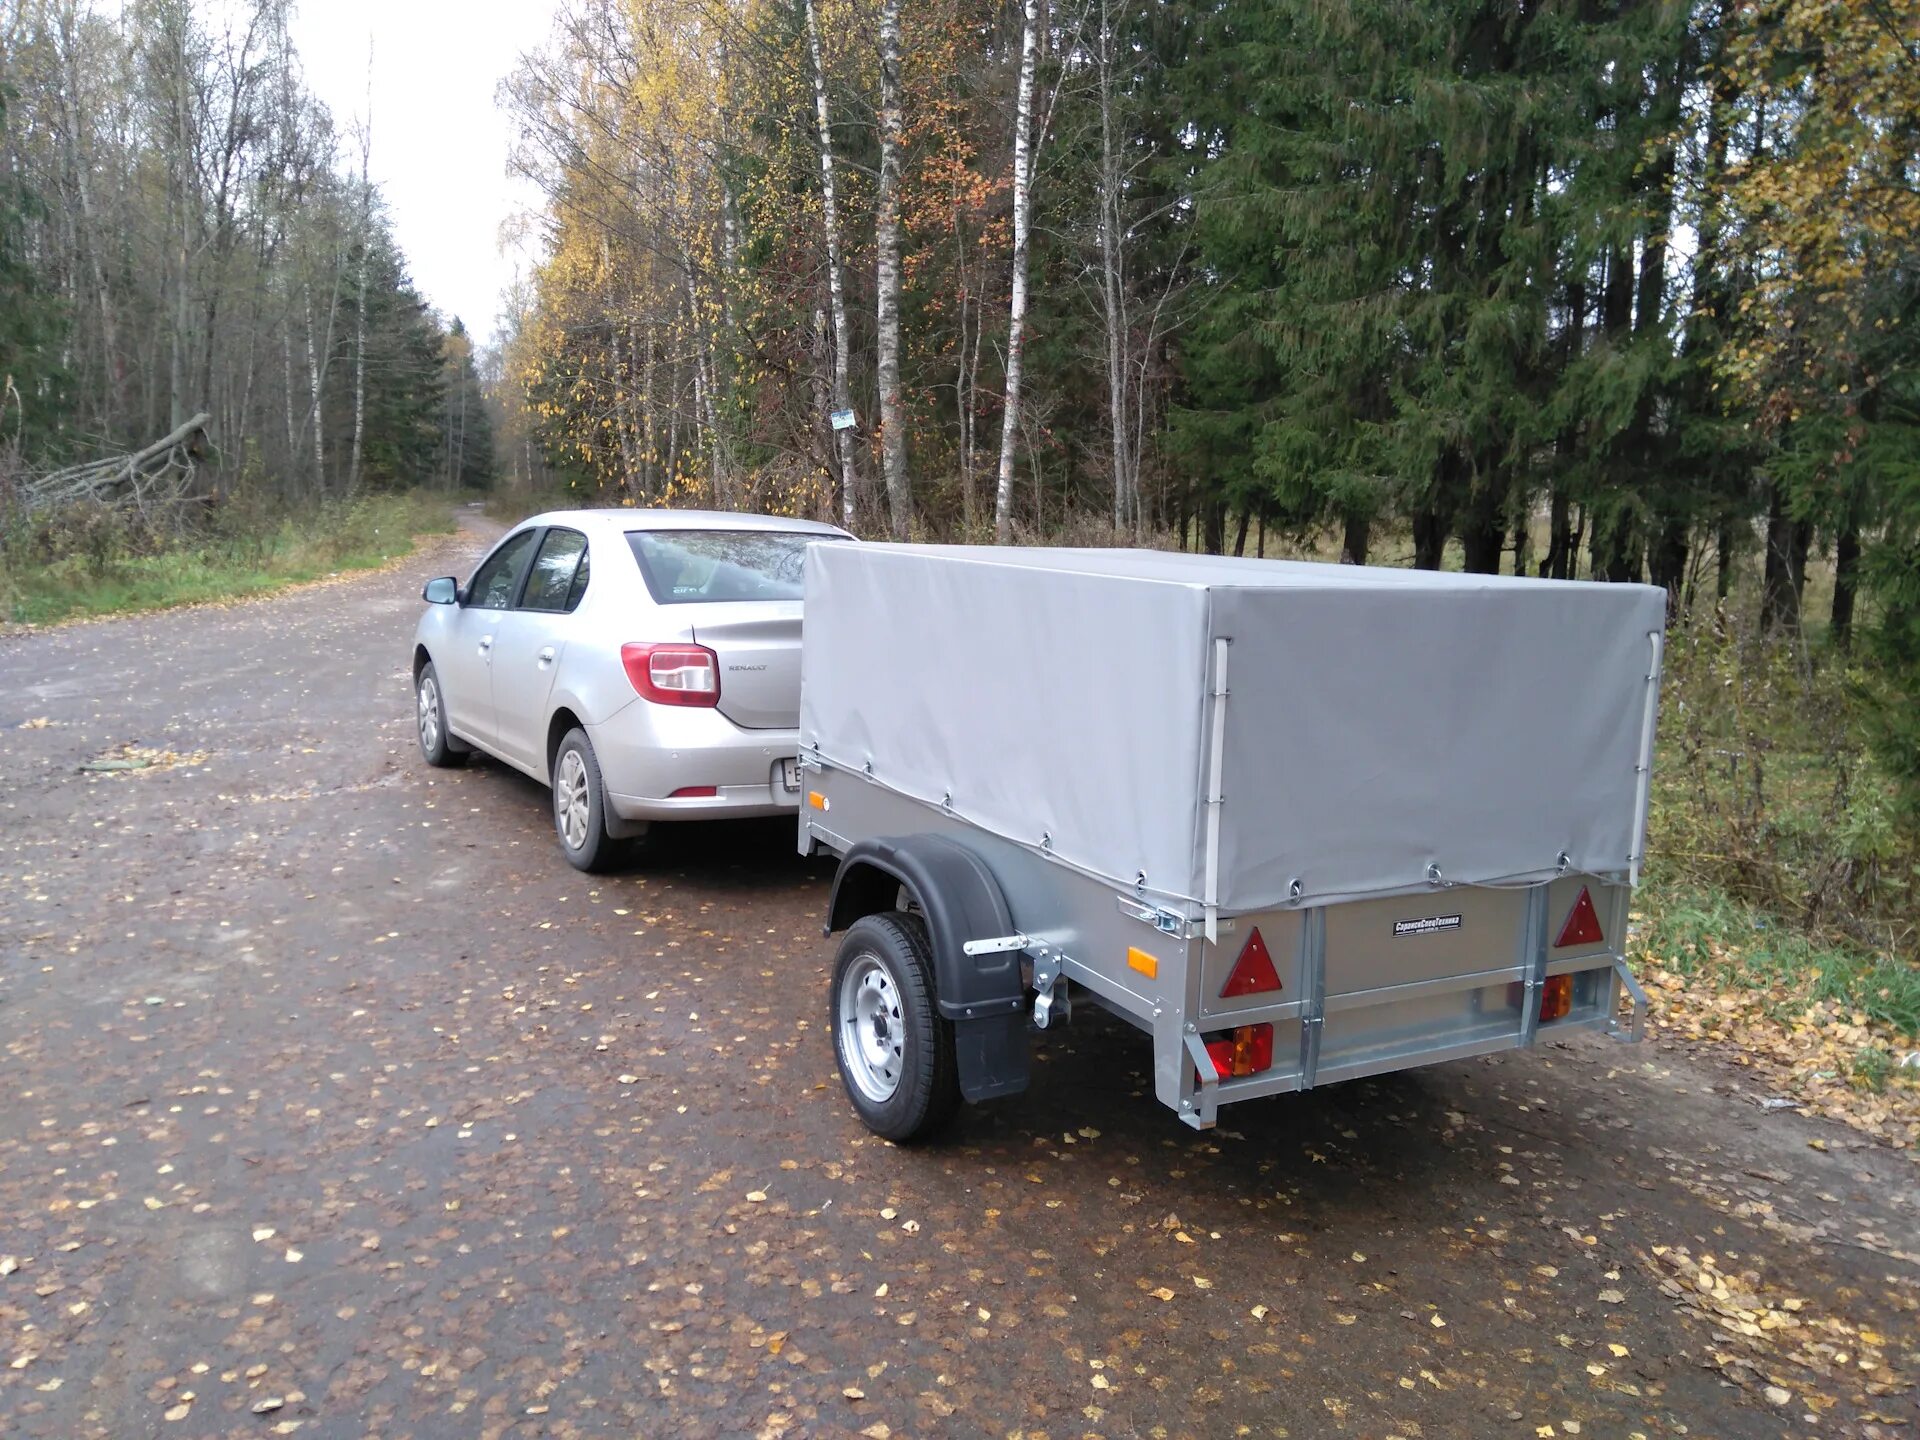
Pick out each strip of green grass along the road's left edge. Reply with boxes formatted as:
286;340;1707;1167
0;493;453;624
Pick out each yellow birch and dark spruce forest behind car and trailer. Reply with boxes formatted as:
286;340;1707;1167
495;0;1920;844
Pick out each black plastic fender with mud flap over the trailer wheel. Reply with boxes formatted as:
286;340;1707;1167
826;835;1027;1100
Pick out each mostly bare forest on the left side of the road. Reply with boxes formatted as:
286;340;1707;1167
0;0;493;518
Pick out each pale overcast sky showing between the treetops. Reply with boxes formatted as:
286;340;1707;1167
294;0;553;349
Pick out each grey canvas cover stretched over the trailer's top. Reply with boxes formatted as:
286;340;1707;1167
801;545;1665;914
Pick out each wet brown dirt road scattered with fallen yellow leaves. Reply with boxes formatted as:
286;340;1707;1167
0;532;1920;1440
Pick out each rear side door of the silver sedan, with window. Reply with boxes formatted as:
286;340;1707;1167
493;526;591;778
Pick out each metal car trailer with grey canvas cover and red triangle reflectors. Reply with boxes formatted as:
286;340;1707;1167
799;545;1665;1140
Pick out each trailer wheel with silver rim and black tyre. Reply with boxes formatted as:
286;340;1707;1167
829;910;960;1142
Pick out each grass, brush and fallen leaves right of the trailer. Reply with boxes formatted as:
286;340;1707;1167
1634;607;1920;1146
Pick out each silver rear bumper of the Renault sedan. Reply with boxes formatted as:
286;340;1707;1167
588;701;801;820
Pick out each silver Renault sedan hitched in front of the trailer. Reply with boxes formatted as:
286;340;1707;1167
413;509;852;870
